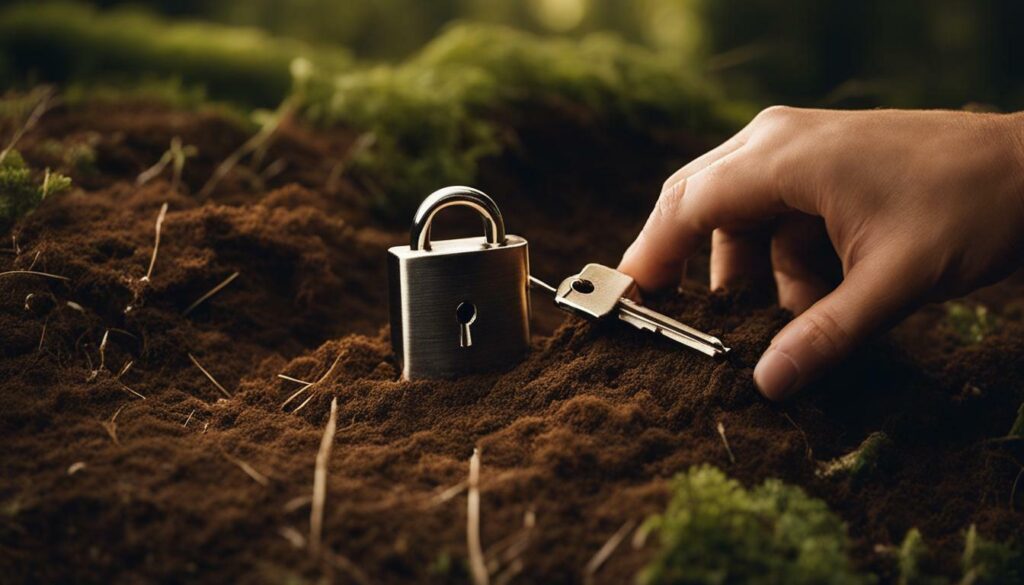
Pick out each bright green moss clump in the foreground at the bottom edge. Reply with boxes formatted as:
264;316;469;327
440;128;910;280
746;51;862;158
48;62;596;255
638;466;872;585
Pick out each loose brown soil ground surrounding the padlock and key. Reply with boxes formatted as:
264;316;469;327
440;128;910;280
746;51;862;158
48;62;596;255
0;103;1024;583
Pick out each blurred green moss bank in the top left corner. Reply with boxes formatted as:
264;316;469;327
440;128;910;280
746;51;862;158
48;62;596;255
0;2;351;106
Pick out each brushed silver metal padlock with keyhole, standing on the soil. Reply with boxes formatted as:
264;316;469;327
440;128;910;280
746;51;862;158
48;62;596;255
388;186;530;379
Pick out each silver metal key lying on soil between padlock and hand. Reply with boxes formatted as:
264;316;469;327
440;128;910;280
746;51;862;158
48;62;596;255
529;263;729;358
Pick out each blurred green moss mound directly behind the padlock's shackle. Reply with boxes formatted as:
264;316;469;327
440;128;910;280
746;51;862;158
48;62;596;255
302;25;733;216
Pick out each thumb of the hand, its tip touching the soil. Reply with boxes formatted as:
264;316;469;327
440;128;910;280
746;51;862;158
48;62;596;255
754;256;918;401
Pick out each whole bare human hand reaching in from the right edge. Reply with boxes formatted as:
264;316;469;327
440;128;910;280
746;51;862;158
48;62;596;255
618;107;1024;400
